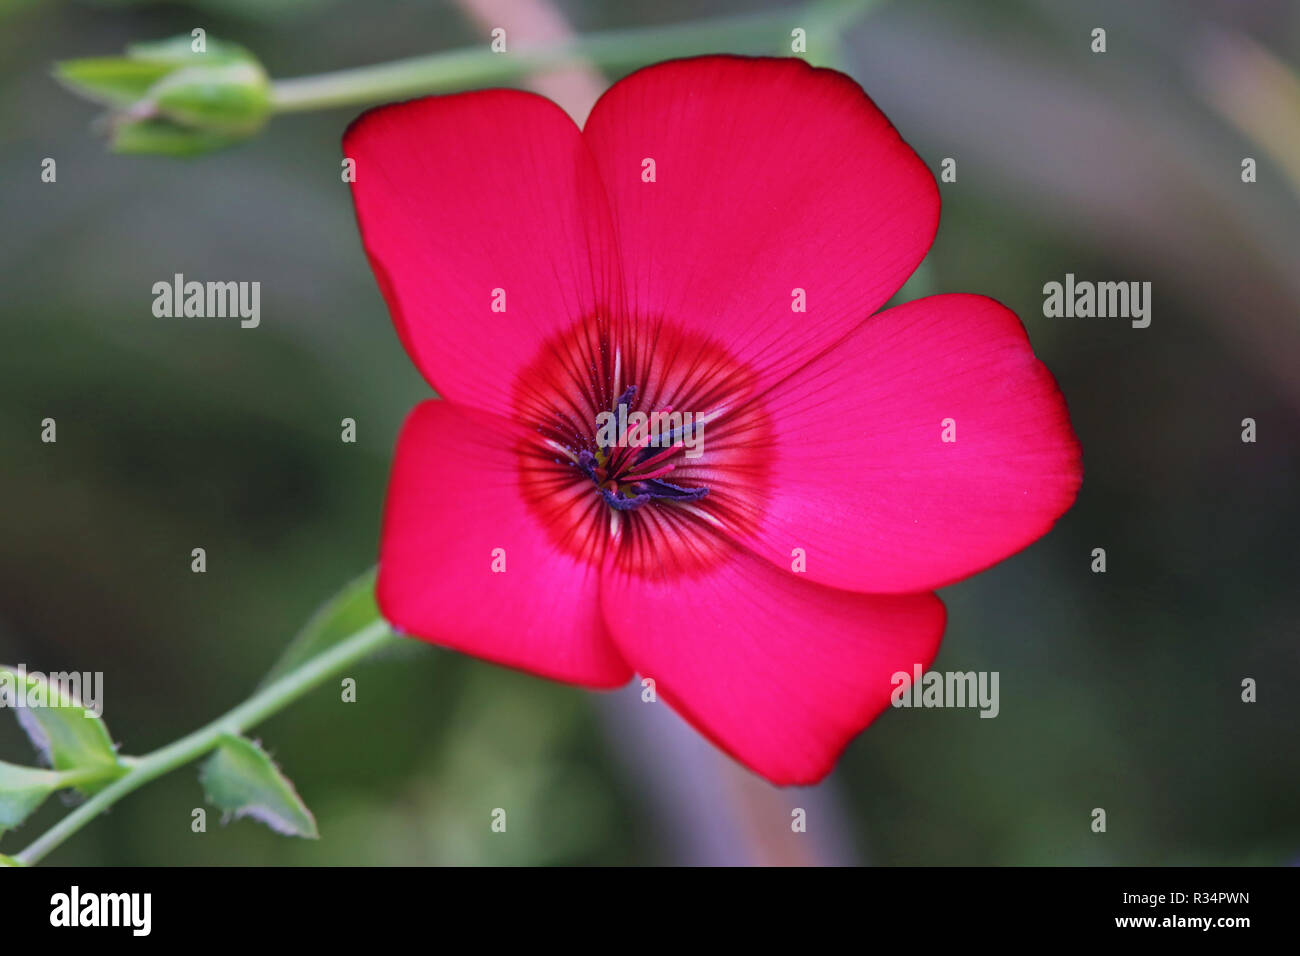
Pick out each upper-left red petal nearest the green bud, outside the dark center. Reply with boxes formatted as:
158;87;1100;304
343;90;618;414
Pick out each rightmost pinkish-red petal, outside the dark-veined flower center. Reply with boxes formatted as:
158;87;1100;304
742;295;1082;592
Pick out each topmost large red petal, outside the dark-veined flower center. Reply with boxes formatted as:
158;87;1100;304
584;56;939;385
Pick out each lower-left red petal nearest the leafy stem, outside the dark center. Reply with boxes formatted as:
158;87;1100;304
377;402;632;687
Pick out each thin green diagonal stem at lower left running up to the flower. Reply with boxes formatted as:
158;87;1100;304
13;620;399;866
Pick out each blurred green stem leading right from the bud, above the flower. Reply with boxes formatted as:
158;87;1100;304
270;0;874;113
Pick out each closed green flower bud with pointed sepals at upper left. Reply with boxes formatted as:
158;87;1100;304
55;35;270;156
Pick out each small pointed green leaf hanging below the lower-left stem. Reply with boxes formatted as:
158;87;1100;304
199;734;320;839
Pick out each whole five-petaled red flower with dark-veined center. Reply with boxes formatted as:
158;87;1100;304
343;56;1080;783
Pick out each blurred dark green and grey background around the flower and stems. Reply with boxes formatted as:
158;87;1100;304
0;0;1300;865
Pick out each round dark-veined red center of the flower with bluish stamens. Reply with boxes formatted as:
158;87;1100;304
515;317;771;574
